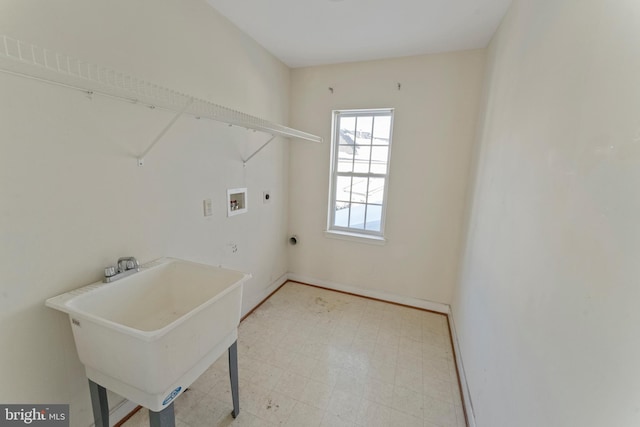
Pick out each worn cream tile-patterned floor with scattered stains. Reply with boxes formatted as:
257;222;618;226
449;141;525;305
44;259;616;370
124;282;466;427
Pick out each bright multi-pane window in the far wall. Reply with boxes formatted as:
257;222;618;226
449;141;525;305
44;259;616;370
328;109;393;238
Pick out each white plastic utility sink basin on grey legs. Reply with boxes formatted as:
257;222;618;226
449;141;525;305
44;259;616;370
46;258;251;412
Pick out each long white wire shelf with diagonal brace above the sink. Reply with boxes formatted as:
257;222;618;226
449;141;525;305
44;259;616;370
0;34;322;166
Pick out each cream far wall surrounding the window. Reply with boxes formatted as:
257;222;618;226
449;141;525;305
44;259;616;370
290;50;484;304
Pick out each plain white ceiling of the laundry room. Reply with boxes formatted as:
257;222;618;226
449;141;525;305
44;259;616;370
207;0;511;68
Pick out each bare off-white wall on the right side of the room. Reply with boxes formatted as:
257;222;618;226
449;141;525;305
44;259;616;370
453;0;640;427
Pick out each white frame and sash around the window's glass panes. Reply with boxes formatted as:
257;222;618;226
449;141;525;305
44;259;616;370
326;108;394;243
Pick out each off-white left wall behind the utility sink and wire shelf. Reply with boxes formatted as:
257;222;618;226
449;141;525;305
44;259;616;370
0;0;289;426
